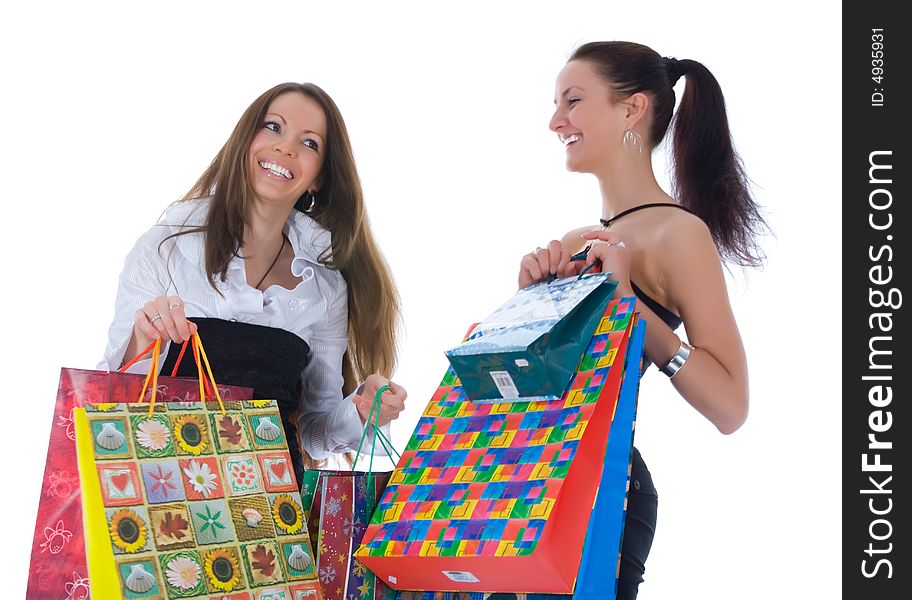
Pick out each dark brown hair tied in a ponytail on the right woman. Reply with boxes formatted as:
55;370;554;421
570;42;767;266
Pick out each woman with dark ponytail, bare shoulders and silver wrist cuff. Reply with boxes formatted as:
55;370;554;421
519;42;766;600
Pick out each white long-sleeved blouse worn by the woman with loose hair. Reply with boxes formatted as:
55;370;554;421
98;200;389;460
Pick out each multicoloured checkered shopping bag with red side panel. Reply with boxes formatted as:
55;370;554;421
356;297;639;594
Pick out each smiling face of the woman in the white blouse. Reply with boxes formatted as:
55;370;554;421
247;92;326;207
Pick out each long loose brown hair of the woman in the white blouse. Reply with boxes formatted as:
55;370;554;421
181;83;401;394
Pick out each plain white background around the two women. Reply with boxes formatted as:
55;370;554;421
0;0;841;600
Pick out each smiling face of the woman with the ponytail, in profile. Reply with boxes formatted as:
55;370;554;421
548;60;627;173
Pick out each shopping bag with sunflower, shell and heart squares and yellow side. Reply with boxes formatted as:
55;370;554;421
75;336;322;600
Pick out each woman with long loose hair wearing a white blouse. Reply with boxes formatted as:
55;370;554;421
100;83;406;475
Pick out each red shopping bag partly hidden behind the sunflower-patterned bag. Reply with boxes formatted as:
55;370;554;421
26;340;253;599
